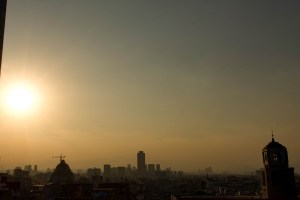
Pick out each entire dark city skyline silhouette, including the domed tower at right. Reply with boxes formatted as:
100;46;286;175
0;138;300;200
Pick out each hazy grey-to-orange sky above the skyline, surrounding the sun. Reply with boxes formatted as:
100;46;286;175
0;0;300;172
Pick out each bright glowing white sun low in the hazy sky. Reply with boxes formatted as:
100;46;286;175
5;84;37;113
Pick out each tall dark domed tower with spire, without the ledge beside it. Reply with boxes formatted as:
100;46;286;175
261;136;296;199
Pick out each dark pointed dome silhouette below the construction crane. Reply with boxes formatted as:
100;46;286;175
50;160;74;183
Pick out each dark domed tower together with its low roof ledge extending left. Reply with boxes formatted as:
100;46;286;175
171;136;299;200
